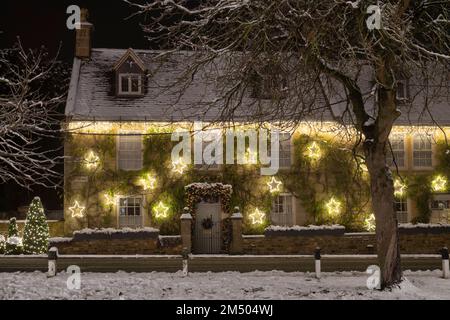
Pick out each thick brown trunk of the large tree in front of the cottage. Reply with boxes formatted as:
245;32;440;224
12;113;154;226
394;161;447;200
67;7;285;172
366;136;402;289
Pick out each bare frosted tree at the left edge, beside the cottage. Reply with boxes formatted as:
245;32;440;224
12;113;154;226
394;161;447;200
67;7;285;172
0;42;68;189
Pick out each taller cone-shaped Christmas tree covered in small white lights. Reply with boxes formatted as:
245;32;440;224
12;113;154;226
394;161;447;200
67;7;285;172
23;197;49;254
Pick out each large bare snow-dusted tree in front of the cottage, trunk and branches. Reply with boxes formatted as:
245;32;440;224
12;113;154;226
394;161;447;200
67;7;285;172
126;0;450;287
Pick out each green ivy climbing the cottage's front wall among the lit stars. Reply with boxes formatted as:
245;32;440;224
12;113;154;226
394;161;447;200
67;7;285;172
65;128;450;234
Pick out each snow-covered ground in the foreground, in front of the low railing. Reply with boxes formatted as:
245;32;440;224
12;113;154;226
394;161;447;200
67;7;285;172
0;271;450;300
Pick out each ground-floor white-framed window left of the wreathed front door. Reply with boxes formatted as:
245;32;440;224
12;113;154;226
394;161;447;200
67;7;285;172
118;196;143;228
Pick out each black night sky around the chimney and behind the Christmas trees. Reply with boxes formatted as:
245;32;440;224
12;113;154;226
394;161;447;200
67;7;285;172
0;0;150;212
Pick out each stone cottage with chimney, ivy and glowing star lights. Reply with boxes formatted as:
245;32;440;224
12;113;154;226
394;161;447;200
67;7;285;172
64;10;450;250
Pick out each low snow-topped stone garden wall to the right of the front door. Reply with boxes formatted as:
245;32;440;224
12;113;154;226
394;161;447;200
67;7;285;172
242;227;450;255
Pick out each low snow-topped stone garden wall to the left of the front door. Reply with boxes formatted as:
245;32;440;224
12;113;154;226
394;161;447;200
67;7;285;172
50;231;182;255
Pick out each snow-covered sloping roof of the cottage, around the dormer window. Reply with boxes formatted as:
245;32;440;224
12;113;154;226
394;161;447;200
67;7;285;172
66;49;450;125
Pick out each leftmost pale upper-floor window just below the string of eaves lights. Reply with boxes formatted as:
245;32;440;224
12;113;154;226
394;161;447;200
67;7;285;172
117;134;142;171
